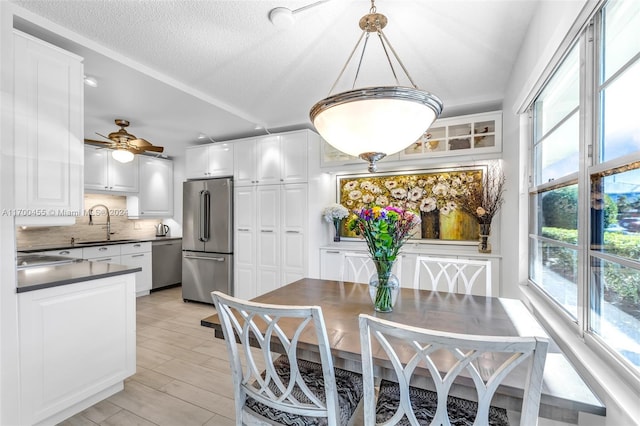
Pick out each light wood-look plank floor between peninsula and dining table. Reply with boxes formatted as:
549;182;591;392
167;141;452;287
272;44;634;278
61;287;235;426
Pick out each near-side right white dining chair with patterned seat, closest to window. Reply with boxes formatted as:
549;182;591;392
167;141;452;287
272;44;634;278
359;314;548;426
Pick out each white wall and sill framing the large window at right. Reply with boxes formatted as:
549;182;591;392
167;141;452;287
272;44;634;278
502;0;640;426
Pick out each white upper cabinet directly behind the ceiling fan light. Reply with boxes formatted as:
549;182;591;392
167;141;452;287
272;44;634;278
84;146;139;193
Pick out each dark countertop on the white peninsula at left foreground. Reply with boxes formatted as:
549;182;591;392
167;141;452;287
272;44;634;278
16;260;142;293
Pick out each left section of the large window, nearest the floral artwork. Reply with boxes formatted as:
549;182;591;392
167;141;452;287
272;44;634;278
529;44;580;319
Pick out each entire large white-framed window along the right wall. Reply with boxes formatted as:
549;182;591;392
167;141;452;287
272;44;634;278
529;1;640;379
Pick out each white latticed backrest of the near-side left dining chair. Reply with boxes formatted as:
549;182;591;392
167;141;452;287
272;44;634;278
211;291;340;425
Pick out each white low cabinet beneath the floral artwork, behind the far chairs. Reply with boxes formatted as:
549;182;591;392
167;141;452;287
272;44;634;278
320;247;500;296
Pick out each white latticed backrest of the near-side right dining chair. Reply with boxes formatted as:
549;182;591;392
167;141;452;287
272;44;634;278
359;314;548;425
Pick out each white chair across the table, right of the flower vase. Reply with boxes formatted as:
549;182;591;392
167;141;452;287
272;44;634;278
413;256;492;297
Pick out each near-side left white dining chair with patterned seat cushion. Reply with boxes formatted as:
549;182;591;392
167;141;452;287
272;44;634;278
211;291;362;426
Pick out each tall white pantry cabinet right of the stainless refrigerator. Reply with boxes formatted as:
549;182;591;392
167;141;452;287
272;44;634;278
234;130;320;299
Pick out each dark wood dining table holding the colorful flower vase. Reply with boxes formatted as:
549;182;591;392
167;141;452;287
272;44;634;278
201;278;606;424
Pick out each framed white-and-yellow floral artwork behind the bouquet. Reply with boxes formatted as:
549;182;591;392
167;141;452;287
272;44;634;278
337;168;483;241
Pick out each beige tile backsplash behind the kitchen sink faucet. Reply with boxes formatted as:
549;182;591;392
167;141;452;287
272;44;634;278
16;194;162;250
